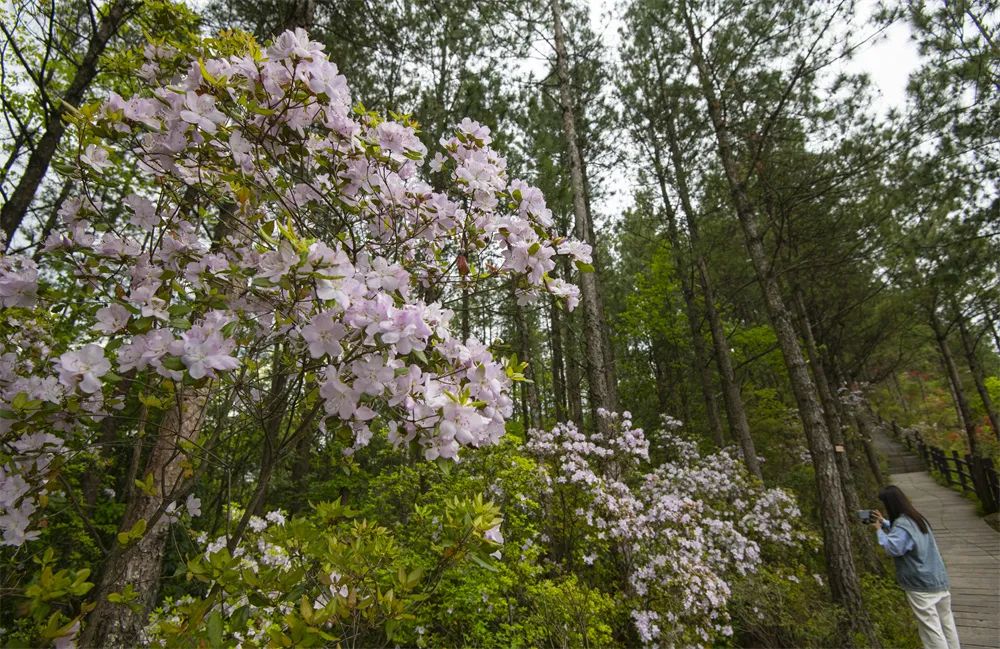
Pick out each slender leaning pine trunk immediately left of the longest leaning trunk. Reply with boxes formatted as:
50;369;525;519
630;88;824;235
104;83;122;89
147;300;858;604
657;86;762;478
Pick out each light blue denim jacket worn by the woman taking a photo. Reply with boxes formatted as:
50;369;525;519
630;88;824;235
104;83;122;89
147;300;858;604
878;514;948;593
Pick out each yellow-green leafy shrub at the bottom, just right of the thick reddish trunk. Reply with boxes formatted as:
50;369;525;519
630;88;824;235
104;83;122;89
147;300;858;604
147;498;503;647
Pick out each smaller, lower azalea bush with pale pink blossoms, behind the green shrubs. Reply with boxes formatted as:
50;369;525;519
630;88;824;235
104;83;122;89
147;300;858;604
527;412;805;646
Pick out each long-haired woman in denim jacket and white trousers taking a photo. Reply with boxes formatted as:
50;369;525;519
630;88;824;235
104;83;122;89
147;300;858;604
872;485;960;649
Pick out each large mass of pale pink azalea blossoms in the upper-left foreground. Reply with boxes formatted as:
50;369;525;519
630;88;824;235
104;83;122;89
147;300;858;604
0;29;590;538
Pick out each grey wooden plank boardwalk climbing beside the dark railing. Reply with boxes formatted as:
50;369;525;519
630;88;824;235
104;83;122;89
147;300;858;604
874;428;1000;649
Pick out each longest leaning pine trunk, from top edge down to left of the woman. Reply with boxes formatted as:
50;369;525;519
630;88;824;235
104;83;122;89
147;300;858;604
680;5;880;647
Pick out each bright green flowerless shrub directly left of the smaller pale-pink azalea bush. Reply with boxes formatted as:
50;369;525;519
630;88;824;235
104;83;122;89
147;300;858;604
344;425;624;647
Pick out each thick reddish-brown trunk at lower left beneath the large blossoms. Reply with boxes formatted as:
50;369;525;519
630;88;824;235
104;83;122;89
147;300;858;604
80;387;209;647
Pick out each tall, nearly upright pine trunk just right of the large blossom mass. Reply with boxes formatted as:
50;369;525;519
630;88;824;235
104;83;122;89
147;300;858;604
552;0;615;428
